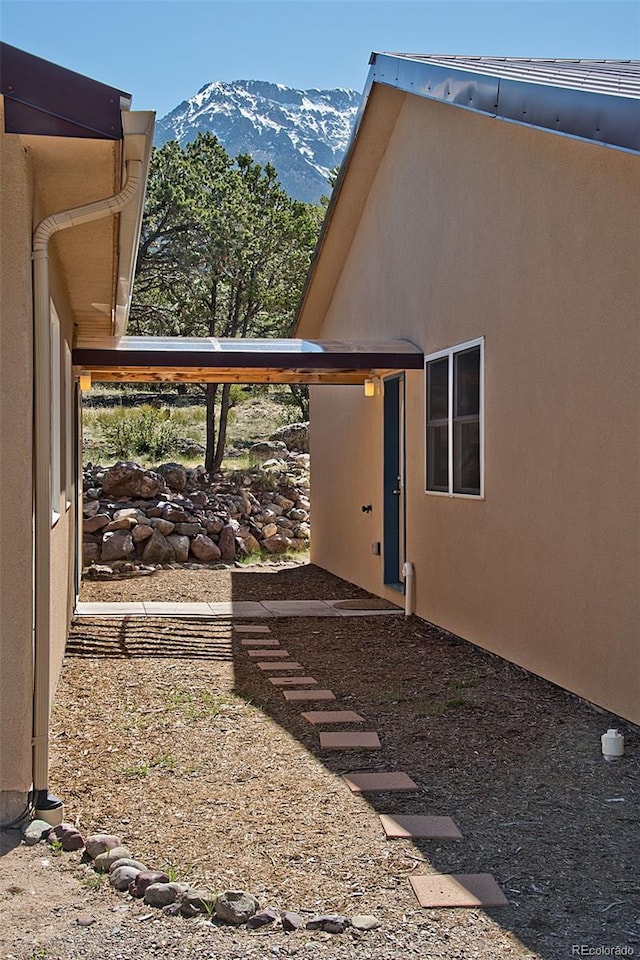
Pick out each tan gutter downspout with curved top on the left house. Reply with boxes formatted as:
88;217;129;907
31;160;142;822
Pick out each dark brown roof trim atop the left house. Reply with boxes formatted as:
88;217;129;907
0;43;131;140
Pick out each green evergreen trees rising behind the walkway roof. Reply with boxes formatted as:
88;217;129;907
130;133;323;472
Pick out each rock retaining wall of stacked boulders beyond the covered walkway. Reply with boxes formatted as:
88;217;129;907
83;443;310;566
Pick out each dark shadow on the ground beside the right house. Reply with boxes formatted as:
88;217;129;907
226;571;640;960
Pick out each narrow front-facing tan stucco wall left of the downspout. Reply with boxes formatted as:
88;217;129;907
0;114;32;821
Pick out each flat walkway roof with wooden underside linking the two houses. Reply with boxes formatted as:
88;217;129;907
73;337;424;384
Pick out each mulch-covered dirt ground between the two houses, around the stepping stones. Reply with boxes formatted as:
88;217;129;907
0;565;640;960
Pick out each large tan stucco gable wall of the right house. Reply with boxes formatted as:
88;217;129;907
308;96;640;722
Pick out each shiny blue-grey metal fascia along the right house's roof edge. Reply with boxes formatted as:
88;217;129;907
368;53;640;154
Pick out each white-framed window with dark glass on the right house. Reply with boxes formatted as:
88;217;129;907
426;342;482;496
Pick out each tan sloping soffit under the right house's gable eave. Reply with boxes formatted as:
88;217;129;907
293;80;405;336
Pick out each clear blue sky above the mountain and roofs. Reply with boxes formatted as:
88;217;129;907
0;0;640;117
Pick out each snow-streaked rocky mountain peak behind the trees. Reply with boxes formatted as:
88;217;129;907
155;80;360;202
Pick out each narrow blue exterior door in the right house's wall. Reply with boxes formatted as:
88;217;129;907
383;374;405;593
